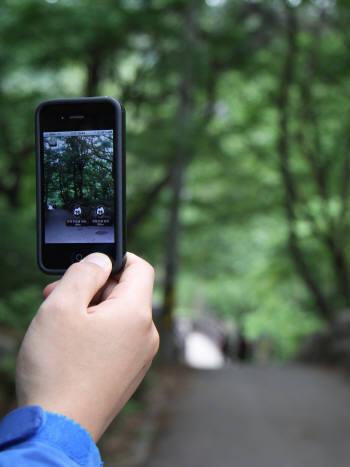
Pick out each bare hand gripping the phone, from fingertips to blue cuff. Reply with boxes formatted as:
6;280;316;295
16;253;159;441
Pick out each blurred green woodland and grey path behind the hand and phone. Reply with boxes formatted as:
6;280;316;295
0;0;350;467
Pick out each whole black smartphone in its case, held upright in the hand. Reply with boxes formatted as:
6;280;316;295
35;97;126;274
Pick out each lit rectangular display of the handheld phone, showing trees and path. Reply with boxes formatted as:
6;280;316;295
43;129;115;244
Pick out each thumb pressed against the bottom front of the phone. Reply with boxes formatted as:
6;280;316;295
47;253;112;309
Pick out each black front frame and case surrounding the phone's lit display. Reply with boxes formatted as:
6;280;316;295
35;97;126;274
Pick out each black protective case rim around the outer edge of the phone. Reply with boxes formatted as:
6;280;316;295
35;97;126;275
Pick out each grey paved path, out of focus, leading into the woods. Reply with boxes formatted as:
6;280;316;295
145;366;350;467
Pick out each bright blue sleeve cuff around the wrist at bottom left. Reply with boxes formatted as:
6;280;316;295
0;406;103;467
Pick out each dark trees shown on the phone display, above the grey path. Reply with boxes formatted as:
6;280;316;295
44;134;114;209
